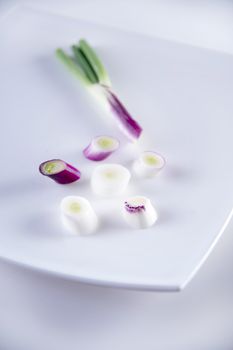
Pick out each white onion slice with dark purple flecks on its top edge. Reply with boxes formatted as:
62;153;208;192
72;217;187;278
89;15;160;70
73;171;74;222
123;196;158;229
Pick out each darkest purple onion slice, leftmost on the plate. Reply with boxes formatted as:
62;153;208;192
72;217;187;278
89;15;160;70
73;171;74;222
39;159;81;185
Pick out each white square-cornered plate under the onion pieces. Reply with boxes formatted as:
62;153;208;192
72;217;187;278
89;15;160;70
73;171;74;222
0;8;233;290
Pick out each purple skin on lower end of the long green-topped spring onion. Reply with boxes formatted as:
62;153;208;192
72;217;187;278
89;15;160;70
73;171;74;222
104;86;143;139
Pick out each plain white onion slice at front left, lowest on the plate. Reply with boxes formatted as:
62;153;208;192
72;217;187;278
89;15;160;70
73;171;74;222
61;196;98;235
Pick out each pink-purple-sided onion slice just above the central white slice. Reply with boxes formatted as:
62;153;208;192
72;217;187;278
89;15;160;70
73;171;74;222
83;136;120;161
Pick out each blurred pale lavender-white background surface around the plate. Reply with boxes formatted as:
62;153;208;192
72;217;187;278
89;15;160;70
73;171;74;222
0;0;233;350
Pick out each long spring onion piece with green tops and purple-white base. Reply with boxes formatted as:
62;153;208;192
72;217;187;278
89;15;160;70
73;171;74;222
56;39;142;140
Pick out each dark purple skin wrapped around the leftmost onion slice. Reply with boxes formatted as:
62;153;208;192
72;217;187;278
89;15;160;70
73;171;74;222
39;159;81;185
